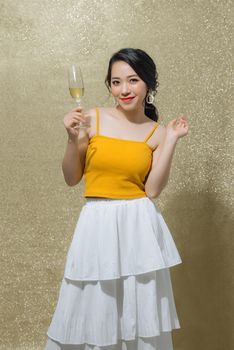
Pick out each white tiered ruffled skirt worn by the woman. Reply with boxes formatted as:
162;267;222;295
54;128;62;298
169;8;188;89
44;197;182;350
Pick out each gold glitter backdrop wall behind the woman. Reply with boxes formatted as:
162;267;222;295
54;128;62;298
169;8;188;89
0;0;234;350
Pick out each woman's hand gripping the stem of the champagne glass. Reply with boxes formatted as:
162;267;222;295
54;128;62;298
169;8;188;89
63;107;86;139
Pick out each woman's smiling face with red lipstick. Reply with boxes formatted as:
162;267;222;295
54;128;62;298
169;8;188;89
110;61;147;110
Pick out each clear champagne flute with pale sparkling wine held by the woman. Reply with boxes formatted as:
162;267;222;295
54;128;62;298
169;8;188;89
68;64;88;129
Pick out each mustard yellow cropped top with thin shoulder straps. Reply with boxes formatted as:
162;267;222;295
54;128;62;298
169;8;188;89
83;108;159;199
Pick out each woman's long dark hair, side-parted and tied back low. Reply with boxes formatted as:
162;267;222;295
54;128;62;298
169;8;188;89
105;48;159;121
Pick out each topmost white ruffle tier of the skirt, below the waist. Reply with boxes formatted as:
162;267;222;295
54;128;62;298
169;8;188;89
65;197;181;281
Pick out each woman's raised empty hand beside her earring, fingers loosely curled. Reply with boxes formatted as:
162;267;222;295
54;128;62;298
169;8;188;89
166;114;188;140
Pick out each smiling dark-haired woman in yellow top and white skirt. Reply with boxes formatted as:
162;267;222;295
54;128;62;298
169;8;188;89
45;48;188;350
